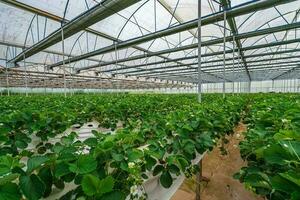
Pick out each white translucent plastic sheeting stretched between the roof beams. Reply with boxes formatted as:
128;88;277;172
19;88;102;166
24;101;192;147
0;0;300;81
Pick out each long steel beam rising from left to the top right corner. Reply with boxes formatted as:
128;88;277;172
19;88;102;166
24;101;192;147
50;0;294;67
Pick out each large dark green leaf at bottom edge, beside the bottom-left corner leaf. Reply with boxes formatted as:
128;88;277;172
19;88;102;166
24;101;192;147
20;174;46;200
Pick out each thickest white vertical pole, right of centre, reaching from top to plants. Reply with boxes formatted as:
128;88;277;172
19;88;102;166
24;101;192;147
198;0;202;103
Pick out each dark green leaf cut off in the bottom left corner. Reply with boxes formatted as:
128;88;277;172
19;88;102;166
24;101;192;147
0;183;22;200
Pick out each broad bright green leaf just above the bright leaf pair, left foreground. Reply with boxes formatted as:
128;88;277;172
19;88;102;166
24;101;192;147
69;155;97;174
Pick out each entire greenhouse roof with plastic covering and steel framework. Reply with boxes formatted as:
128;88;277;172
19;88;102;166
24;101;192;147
0;0;300;88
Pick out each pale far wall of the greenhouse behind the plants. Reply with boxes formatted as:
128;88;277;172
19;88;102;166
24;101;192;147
0;79;300;95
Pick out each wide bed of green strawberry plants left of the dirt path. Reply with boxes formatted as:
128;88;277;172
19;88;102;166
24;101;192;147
0;95;246;200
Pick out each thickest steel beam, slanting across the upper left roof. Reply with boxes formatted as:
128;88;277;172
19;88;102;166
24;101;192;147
6;0;139;63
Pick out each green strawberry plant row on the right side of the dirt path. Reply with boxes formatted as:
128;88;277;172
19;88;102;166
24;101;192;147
235;94;300;200
